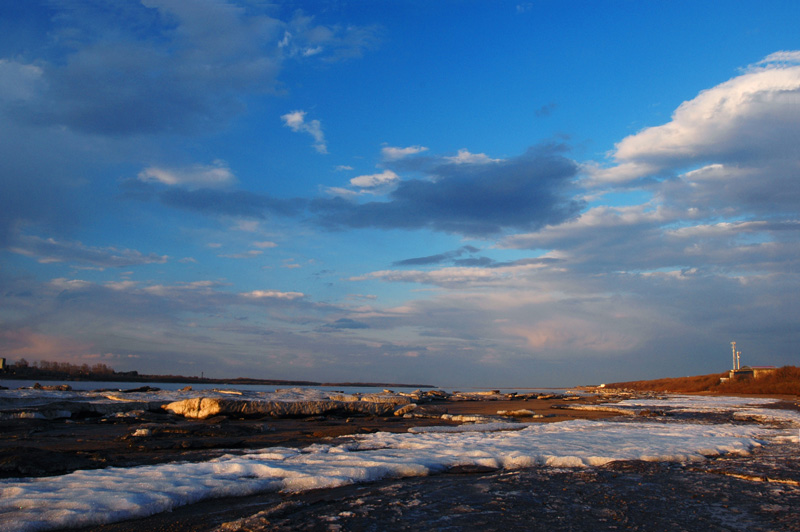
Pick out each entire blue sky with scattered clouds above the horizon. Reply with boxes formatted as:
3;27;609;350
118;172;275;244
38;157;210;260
0;0;800;387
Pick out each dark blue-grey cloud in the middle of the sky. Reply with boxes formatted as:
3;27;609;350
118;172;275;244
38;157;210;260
311;145;582;235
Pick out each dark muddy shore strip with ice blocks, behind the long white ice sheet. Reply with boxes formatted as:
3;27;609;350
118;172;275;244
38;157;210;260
0;387;614;478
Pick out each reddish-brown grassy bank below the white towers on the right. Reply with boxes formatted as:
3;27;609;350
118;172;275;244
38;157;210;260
606;366;800;395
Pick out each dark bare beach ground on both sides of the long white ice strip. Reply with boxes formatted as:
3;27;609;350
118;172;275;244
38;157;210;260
0;388;800;532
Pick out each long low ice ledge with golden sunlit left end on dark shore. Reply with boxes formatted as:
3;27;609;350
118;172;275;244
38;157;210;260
163;397;395;419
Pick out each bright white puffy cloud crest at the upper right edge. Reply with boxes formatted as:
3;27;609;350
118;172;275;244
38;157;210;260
593;51;800;183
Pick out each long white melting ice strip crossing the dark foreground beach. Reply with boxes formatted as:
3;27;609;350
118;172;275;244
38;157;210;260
0;394;797;532
